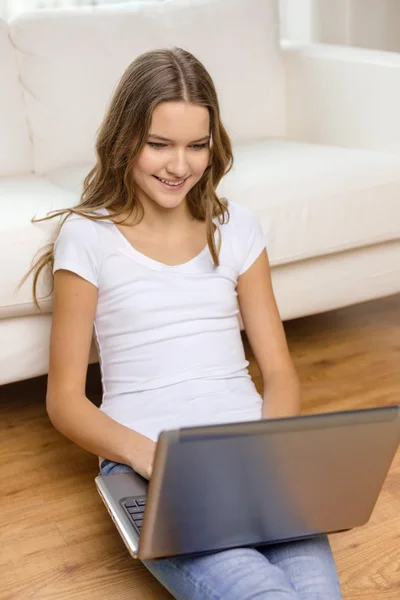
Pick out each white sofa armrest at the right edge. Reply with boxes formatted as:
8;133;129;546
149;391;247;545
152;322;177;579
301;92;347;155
282;42;400;154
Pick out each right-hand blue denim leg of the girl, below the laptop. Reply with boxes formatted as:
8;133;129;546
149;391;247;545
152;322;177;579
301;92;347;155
258;535;342;600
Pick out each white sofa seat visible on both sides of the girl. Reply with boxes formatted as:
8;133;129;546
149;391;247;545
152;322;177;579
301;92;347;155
0;140;400;318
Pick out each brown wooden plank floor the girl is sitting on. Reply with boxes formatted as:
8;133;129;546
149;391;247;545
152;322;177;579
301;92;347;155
0;296;400;600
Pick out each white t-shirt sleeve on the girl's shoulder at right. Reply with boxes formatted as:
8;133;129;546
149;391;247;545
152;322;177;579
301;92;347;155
234;205;267;275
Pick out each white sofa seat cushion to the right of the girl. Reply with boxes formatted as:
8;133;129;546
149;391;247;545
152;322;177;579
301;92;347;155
218;140;400;265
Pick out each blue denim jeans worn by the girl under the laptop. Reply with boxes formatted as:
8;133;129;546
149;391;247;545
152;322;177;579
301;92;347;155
100;460;342;600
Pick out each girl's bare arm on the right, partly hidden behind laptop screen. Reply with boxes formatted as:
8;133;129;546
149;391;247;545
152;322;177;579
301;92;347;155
237;250;301;418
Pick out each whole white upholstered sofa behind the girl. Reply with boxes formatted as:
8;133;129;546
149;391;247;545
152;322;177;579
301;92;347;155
0;0;400;384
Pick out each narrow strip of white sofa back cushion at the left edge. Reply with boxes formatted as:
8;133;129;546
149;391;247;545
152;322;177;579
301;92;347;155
0;19;32;177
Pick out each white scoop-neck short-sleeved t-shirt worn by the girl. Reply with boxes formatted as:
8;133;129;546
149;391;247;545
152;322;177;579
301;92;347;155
53;202;266;441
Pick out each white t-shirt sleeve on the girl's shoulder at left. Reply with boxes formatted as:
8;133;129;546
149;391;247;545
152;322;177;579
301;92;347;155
53;215;101;287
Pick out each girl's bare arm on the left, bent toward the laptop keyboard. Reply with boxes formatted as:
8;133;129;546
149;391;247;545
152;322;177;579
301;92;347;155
46;269;156;478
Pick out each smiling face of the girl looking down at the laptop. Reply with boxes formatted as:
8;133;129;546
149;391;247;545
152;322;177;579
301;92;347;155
133;102;210;209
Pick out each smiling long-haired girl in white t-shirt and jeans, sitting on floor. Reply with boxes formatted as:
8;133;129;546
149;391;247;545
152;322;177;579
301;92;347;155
25;48;341;600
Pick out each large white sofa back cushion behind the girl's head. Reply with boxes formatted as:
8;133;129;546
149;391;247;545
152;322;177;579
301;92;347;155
10;0;285;173
